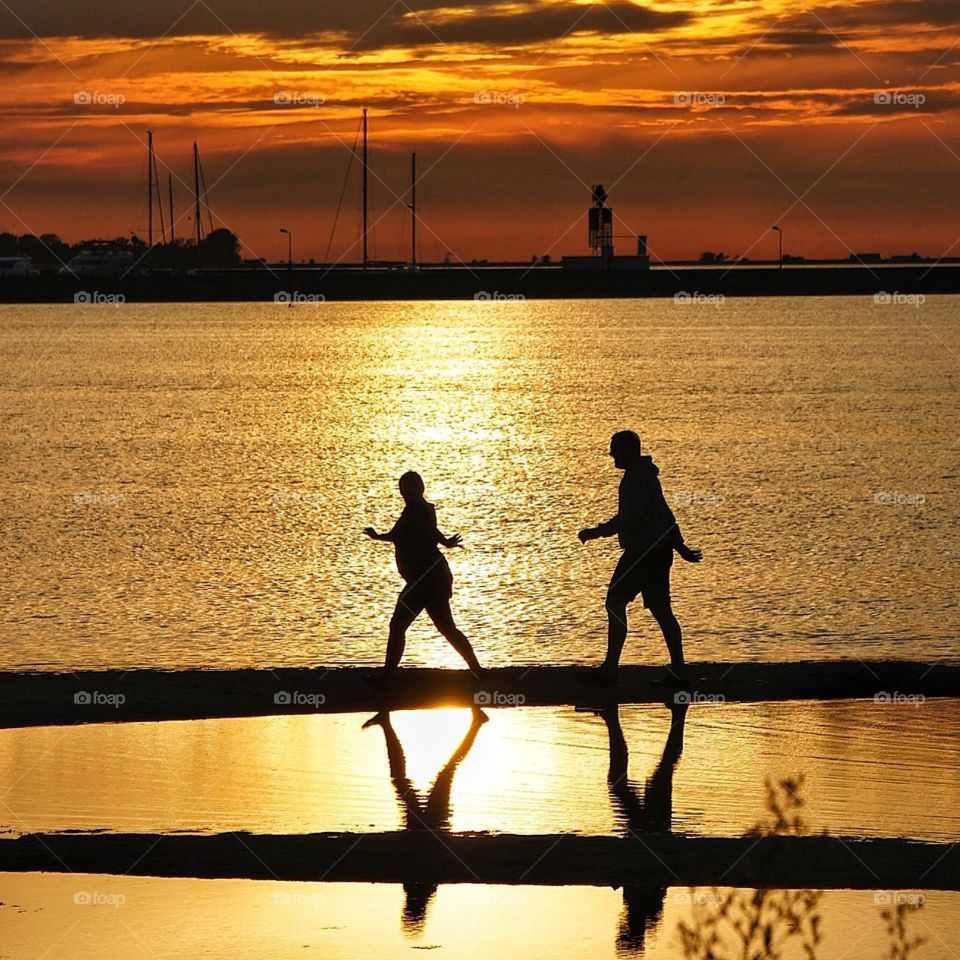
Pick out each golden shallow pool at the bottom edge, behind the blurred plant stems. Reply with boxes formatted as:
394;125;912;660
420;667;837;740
0;874;960;960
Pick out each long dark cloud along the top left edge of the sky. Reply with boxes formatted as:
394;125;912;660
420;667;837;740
0;0;690;49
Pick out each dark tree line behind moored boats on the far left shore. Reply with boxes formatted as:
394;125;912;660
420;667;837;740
0;227;240;273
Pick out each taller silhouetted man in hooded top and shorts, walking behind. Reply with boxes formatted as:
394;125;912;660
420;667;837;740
578;430;703;686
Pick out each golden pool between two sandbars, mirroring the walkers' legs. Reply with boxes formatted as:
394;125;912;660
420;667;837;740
0;700;960;842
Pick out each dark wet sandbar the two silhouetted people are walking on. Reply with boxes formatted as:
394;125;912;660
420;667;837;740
0;660;960;727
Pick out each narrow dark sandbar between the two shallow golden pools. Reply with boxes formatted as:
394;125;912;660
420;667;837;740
0;830;960;890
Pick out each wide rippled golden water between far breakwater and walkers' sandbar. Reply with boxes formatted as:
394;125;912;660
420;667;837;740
0;297;960;668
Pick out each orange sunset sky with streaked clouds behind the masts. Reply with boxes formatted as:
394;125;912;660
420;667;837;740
0;0;960;260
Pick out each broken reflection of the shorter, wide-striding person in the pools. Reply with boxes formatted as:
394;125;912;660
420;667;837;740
363;707;489;934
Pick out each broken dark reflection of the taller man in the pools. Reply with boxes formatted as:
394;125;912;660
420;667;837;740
598;703;687;956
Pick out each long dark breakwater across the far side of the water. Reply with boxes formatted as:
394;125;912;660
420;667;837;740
0;261;960;307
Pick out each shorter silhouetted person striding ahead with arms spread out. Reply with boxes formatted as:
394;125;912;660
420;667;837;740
363;471;482;688
